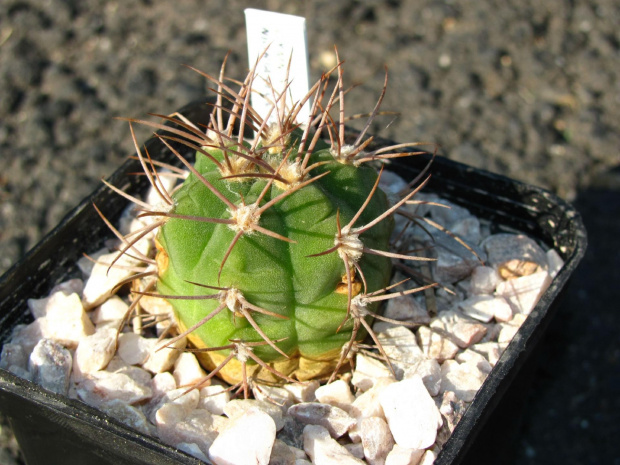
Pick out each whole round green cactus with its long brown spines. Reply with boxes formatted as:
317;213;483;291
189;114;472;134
104;54;436;396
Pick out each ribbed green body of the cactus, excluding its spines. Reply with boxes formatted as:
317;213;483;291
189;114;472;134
158;131;393;381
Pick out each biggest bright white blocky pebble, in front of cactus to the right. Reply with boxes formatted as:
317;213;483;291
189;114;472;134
379;376;442;449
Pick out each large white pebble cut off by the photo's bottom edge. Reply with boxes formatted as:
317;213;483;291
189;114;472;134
209;410;276;465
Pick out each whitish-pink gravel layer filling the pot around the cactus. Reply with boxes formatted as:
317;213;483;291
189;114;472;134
0;179;561;465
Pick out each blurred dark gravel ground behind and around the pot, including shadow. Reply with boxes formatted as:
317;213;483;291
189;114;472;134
0;0;620;465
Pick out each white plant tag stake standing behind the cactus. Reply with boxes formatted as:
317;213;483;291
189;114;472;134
245;8;311;123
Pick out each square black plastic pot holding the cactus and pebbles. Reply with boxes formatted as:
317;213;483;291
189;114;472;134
0;102;586;465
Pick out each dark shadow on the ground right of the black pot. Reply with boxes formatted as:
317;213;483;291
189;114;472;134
514;189;620;465
